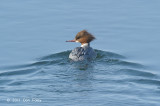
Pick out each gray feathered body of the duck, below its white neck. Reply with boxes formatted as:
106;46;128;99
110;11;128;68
69;46;97;61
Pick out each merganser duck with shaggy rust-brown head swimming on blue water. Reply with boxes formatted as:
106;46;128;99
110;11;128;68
66;30;97;61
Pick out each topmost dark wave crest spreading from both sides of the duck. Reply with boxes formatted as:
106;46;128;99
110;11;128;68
1;50;144;70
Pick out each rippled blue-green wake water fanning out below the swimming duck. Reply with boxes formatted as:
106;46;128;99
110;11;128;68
0;50;160;106
